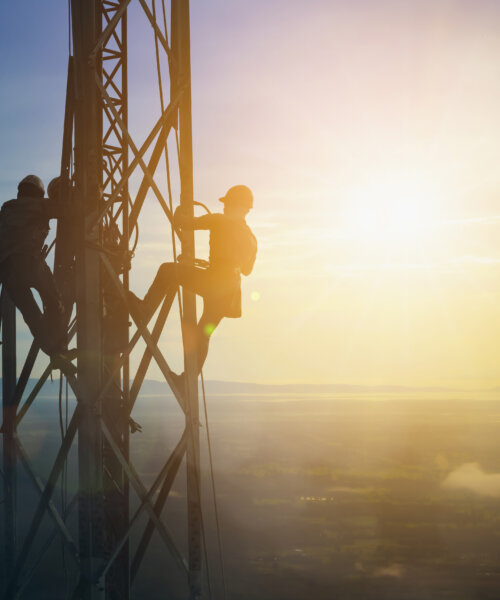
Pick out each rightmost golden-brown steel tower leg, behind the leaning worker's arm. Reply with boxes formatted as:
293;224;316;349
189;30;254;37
172;0;201;600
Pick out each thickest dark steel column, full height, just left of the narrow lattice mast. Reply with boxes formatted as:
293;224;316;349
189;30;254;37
72;0;104;600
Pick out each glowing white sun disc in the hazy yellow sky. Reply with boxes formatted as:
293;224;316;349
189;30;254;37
344;176;439;246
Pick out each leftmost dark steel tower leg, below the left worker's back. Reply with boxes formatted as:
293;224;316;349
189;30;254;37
1;290;17;583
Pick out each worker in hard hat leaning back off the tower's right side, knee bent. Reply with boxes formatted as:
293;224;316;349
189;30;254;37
130;185;257;390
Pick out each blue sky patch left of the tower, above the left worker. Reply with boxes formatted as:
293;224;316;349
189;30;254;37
0;1;68;199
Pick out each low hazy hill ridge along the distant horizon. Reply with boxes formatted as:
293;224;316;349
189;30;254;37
0;378;457;398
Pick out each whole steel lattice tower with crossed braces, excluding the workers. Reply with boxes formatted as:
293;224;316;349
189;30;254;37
2;0;207;600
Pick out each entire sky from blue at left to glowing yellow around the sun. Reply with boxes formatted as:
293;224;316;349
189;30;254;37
0;0;500;388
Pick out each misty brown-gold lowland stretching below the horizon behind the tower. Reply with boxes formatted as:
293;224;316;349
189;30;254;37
2;382;500;600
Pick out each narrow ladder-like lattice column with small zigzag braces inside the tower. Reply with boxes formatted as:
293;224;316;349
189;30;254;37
99;0;130;600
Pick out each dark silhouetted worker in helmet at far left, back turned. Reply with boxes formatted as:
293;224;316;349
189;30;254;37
0;175;65;356
